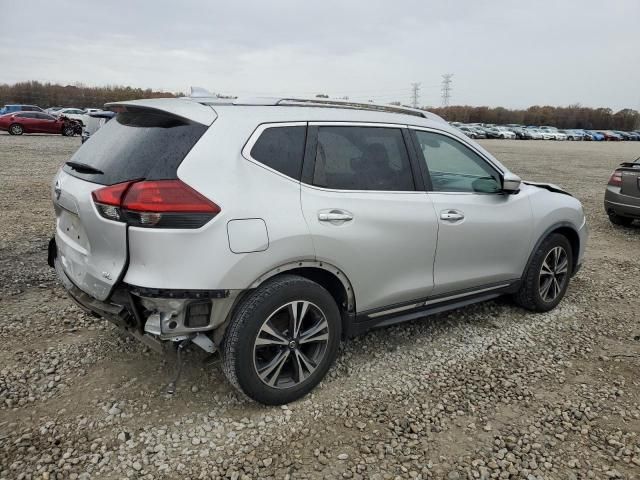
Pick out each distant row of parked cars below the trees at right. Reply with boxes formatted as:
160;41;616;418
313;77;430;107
451;122;640;141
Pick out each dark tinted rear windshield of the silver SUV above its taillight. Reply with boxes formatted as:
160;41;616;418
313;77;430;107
63;108;208;185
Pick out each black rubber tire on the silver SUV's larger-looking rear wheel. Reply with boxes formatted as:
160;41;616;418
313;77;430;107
222;275;341;405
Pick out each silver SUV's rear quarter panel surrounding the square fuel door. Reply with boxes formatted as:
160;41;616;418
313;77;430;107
124;112;315;289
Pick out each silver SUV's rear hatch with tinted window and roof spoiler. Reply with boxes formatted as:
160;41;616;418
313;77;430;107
53;99;216;300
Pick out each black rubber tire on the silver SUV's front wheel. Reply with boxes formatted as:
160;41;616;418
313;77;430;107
513;233;573;312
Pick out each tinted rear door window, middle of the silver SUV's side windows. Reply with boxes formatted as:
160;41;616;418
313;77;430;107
313;126;415;191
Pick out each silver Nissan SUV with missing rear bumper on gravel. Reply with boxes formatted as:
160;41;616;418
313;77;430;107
49;98;587;404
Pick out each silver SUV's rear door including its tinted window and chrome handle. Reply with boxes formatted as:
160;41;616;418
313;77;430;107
301;123;438;313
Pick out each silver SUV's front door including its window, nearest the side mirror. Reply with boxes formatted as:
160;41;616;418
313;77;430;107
413;130;533;295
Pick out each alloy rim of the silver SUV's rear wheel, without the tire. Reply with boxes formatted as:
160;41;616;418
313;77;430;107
253;300;330;388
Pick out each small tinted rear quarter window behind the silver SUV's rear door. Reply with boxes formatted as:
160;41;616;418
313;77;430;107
251;125;307;180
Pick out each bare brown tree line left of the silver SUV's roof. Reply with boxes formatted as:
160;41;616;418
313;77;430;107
0;81;184;108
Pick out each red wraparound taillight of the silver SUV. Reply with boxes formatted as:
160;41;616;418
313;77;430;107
92;180;220;228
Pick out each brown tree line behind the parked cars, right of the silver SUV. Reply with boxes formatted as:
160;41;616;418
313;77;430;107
427;105;640;131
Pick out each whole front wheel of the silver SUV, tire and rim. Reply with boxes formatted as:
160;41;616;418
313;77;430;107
514;233;573;312
